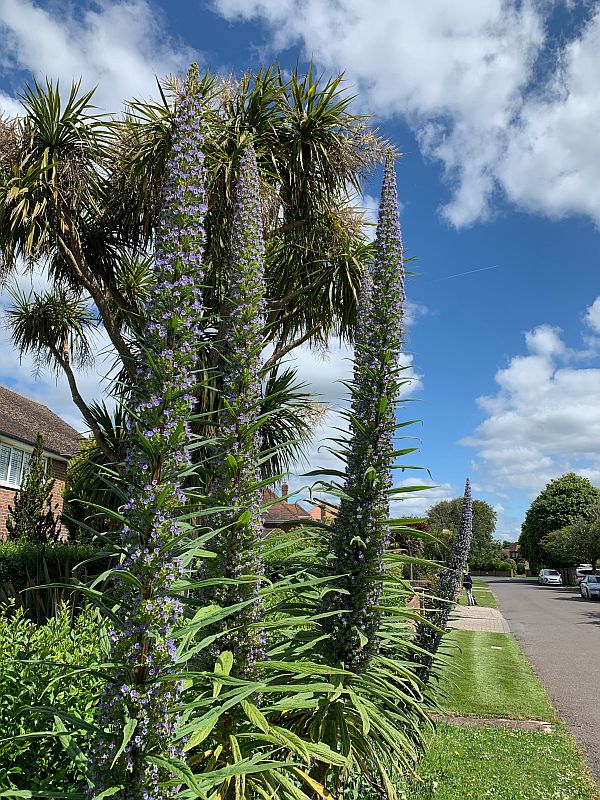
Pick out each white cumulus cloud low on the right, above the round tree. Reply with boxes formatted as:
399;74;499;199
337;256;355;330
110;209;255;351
463;298;600;492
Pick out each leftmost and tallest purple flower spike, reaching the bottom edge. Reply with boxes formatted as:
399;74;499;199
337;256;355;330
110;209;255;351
89;67;206;800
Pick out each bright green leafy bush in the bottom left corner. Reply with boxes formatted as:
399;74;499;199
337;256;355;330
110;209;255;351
0;606;101;792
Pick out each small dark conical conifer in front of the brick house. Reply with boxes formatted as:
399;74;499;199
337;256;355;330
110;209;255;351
6;434;60;544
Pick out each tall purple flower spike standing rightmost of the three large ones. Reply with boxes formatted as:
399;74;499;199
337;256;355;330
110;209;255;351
324;154;404;671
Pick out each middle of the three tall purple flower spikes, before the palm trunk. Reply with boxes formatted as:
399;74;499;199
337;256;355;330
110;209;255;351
207;145;265;677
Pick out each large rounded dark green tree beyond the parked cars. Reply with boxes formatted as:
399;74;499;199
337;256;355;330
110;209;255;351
519;472;600;570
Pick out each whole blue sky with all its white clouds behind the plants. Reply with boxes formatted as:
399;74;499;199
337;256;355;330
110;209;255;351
0;0;600;539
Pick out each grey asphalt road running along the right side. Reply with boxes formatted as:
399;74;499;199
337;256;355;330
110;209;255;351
487;578;600;779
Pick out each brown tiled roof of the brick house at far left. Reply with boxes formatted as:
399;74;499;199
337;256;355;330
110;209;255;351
0;386;82;458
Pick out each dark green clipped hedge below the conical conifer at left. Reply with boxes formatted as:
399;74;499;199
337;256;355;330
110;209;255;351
0;542;109;590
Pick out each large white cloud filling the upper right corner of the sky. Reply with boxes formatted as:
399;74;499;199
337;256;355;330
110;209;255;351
213;0;600;226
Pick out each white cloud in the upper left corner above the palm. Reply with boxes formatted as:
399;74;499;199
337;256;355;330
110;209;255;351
0;0;193;114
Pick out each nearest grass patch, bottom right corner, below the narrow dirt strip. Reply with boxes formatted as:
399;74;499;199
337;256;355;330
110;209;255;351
408;725;599;800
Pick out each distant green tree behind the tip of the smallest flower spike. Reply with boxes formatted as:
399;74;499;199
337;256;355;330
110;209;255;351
426;497;500;567
